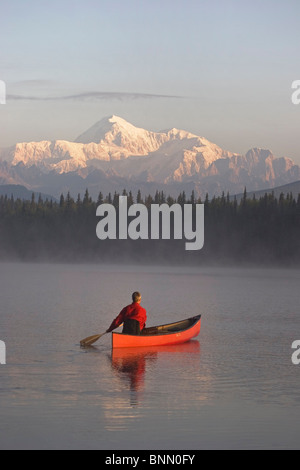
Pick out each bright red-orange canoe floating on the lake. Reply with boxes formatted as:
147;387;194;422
112;315;201;349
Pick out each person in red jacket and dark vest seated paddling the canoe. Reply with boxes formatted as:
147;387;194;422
106;292;147;335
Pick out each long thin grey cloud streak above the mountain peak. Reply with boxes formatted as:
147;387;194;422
7;91;184;101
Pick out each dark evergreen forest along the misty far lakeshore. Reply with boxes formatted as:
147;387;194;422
0;190;300;266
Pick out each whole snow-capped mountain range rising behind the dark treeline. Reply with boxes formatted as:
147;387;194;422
0;116;300;196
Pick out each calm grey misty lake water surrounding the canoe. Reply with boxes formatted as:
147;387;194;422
0;264;300;450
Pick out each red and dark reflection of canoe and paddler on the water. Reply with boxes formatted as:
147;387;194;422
111;340;200;404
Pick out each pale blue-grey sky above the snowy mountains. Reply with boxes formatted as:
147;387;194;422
0;0;300;164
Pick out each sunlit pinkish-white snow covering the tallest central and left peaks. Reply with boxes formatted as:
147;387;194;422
2;116;232;181
